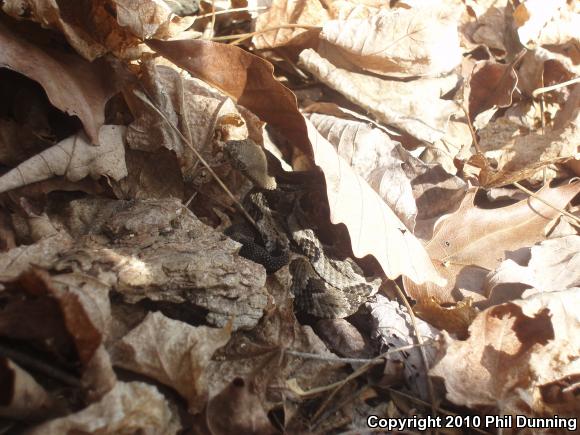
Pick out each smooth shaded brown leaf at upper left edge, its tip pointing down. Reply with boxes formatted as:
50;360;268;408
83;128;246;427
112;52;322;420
0;22;115;144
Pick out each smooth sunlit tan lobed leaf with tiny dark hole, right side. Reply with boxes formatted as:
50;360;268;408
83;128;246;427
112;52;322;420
405;183;580;304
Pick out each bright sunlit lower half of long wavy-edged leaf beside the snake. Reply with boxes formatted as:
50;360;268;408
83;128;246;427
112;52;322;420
306;121;442;283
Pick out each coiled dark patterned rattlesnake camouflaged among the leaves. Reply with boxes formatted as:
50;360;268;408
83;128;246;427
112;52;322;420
224;140;381;318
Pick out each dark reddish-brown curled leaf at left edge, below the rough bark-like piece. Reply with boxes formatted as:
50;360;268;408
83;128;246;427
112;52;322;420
0;268;116;398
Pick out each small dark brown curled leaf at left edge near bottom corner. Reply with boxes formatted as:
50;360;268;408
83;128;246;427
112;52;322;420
0;357;55;420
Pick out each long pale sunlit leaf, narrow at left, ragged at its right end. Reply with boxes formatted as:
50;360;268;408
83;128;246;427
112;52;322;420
300;49;458;142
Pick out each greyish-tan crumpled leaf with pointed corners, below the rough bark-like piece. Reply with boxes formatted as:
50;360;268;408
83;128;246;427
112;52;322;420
113;312;231;414
